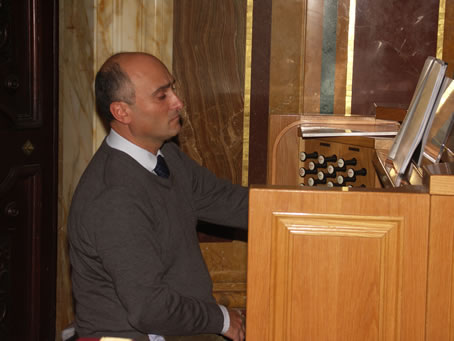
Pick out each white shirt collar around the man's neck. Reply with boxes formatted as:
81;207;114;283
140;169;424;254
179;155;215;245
106;129;164;173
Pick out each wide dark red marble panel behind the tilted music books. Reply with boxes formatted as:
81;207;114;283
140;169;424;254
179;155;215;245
352;0;439;115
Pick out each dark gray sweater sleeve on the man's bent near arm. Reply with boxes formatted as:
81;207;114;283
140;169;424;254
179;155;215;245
88;189;223;335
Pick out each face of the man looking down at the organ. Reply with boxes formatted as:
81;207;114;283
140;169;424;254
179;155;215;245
127;56;183;149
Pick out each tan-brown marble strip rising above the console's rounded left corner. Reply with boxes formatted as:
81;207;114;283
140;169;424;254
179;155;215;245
269;0;306;115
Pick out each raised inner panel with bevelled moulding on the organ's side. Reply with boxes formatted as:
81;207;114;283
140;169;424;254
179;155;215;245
270;213;403;340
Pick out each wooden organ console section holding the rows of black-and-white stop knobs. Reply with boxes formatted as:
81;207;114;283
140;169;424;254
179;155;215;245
267;115;399;187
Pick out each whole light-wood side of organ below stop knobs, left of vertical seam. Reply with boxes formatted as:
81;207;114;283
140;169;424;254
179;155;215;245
247;188;430;341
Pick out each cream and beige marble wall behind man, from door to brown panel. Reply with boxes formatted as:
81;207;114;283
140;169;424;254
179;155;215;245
56;0;173;340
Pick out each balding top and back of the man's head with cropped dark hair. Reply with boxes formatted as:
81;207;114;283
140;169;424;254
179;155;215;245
95;52;165;123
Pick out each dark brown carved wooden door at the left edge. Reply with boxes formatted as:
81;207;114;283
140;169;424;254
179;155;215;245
0;0;58;341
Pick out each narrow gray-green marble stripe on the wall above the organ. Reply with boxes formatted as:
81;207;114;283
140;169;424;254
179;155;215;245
320;0;338;113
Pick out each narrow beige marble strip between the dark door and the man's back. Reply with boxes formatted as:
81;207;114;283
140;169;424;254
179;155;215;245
56;0;94;334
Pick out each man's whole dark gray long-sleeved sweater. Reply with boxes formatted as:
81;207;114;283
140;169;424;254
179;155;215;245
68;141;248;338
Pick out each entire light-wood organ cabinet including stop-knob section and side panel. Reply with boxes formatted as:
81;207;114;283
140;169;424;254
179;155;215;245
246;115;454;341
